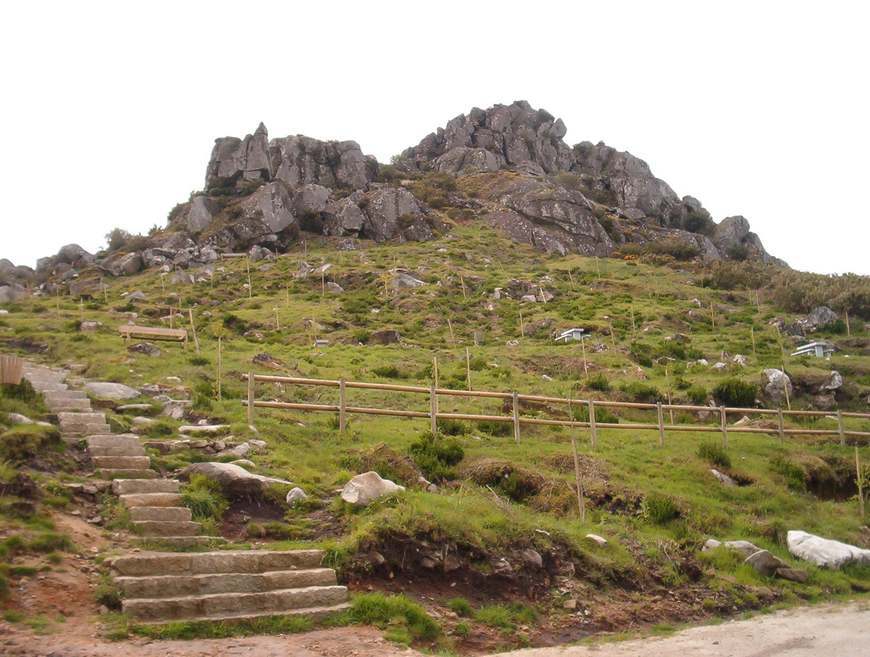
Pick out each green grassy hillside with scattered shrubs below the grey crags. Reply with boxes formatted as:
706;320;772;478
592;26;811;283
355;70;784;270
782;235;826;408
0;225;870;651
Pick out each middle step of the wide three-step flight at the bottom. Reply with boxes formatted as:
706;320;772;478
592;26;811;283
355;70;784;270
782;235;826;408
115;568;336;599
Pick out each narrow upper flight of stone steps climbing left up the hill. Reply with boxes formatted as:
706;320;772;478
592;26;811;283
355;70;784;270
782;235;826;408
24;363;211;547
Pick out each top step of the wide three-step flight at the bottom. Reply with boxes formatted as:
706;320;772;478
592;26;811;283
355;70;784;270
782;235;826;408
112;550;323;577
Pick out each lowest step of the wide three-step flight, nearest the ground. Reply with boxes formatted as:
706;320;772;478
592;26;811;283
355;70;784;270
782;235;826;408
123;586;347;621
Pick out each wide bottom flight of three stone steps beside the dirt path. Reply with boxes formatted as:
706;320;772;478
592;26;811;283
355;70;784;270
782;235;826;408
111;550;348;623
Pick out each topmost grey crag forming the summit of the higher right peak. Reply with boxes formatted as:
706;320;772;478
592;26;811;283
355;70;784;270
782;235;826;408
401;100;572;173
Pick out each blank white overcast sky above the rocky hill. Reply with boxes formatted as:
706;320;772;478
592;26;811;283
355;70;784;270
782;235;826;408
0;0;870;274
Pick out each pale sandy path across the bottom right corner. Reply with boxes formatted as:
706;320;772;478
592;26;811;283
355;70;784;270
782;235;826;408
494;602;870;657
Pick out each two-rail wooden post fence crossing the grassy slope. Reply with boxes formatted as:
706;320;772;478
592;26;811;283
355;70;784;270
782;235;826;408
243;372;870;448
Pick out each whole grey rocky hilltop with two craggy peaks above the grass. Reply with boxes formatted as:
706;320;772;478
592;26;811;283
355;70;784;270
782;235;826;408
0;101;784;297
